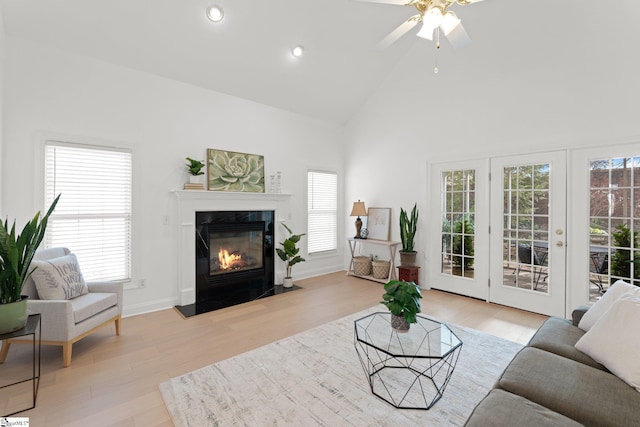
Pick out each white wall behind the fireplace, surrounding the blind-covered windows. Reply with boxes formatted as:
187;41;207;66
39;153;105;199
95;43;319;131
2;37;344;314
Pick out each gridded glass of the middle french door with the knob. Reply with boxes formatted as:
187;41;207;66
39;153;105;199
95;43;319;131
503;164;550;293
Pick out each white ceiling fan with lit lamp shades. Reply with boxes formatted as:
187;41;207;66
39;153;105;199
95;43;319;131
358;0;482;49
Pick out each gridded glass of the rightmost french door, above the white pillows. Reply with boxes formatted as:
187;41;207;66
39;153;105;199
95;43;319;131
588;157;640;301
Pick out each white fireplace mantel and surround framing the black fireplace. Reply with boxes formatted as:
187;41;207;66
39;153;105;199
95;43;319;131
172;190;291;305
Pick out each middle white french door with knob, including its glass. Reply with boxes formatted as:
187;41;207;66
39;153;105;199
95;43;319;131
489;151;567;317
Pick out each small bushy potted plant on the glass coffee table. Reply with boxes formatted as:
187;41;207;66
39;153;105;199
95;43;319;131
380;280;422;332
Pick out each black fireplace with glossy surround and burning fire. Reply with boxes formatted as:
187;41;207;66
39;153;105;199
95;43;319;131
195;210;275;314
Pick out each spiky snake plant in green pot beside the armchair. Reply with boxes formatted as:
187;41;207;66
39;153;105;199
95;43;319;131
0;195;60;334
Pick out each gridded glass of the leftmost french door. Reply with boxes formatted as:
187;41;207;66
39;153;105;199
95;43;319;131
440;169;476;278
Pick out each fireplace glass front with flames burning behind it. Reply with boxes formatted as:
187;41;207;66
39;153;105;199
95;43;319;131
209;230;264;276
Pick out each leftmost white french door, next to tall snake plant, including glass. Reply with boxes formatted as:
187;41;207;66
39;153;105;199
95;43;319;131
429;161;489;300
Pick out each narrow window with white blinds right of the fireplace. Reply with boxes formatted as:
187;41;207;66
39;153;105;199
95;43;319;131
307;171;338;254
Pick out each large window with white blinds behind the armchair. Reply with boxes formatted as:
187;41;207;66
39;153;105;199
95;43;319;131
44;141;132;281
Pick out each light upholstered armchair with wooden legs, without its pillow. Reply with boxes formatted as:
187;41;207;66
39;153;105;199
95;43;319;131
0;248;123;368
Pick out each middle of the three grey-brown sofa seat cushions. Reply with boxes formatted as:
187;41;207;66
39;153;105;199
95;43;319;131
498;347;640;427
